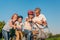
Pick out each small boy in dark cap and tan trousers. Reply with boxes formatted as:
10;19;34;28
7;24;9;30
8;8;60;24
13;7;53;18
15;16;23;40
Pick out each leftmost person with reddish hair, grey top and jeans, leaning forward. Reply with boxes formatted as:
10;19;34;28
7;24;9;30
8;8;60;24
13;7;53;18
2;14;18;40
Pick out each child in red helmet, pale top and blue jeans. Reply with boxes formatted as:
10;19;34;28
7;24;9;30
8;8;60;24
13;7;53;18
24;11;34;40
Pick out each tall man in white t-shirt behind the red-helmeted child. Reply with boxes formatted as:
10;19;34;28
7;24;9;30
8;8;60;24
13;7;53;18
33;8;47;40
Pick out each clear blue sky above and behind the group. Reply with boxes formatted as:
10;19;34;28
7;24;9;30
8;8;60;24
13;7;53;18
0;0;60;34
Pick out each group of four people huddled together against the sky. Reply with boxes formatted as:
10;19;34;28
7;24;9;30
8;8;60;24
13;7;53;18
2;8;47;40
